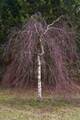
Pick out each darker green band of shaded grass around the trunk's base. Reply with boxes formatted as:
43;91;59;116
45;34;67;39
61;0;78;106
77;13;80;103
0;97;77;109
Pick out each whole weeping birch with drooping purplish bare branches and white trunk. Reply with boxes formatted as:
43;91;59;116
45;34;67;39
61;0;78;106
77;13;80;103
2;14;79;99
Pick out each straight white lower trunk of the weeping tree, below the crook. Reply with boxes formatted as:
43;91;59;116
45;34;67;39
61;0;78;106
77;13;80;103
38;55;42;100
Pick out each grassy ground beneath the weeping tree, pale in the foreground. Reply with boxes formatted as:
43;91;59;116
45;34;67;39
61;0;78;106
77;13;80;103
0;89;80;120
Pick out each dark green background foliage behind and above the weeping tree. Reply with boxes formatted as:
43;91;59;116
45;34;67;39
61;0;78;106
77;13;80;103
0;0;80;81
